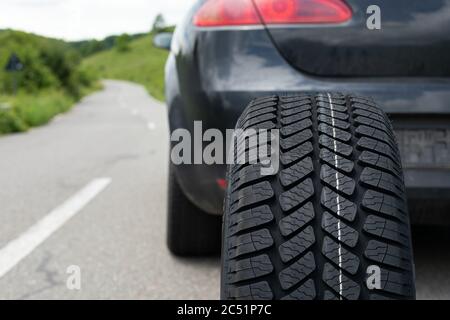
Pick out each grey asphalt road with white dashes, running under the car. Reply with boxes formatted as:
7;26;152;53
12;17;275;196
0;81;450;299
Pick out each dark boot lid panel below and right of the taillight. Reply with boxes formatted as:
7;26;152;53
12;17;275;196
268;0;450;78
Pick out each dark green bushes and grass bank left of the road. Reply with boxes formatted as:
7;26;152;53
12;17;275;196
0;30;98;134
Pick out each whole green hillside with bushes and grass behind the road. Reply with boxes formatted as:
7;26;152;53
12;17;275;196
0;30;168;135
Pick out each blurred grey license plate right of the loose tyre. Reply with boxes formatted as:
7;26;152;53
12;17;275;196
395;129;450;169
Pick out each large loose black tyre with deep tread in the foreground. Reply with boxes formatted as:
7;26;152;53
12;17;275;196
221;93;415;300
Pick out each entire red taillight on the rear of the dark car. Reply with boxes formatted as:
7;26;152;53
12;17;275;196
194;0;352;27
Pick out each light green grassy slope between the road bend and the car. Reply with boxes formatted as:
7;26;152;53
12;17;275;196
82;35;168;101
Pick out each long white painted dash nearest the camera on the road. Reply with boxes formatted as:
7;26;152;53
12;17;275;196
0;178;111;278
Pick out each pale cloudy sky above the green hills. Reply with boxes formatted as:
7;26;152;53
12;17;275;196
0;0;195;41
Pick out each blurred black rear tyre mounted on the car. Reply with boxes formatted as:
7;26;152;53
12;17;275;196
167;165;222;256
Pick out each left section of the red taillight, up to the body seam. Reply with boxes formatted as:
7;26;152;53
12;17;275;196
194;0;261;27
